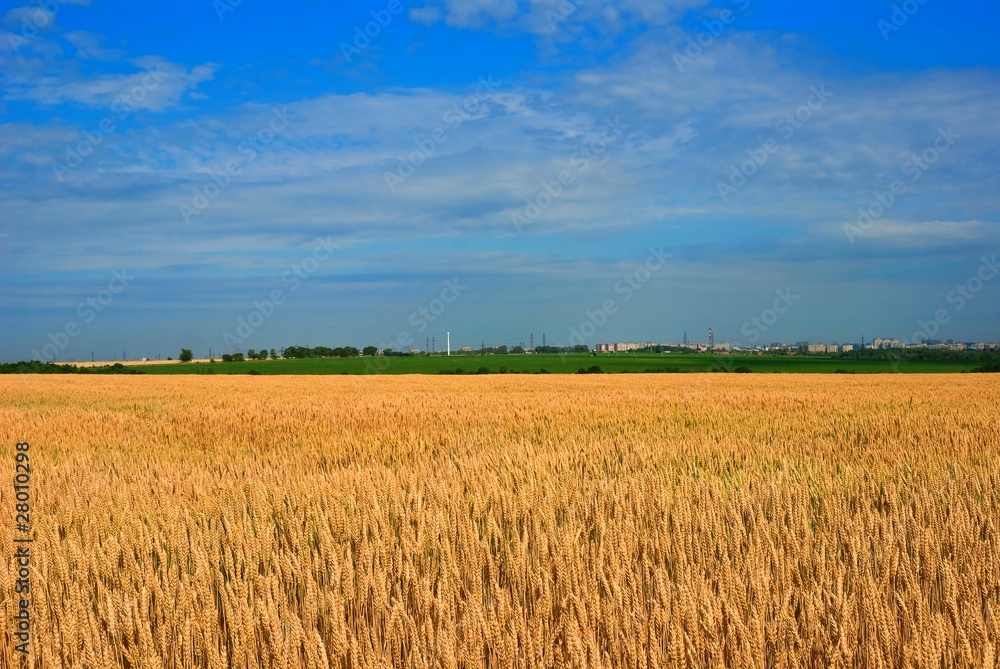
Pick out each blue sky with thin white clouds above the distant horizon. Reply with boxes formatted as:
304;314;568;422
0;0;1000;360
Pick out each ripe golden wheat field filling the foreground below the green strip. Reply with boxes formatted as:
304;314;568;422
0;374;1000;669
